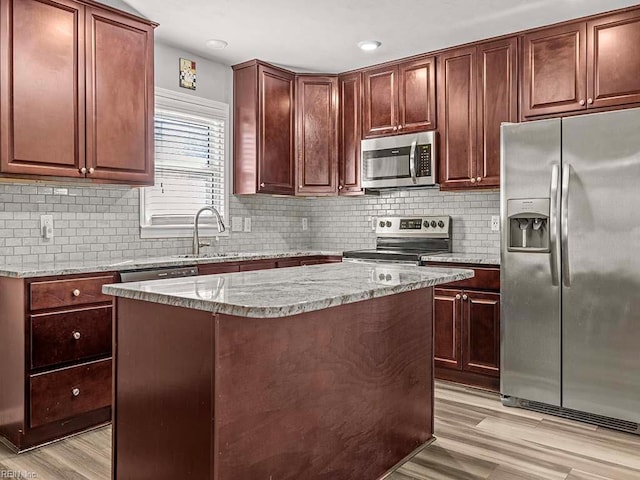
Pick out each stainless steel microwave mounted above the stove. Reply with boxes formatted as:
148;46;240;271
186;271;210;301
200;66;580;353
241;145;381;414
360;132;437;189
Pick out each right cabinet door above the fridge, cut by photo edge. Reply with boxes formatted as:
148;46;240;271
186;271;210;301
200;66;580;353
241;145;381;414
587;10;640;107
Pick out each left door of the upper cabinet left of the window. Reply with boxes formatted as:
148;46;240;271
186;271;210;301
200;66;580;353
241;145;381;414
0;0;85;177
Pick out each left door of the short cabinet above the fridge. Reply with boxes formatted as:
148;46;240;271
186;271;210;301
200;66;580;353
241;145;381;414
521;22;587;118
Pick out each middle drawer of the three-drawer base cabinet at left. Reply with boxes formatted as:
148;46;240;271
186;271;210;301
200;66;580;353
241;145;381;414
31;307;112;368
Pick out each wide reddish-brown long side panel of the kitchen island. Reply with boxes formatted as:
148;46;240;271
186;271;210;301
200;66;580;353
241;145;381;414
214;288;433;480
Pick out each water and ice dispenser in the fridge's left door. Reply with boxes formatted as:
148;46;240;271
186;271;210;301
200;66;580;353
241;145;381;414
507;198;550;253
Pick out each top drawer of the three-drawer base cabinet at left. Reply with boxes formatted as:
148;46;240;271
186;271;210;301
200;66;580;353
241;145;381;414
29;275;115;310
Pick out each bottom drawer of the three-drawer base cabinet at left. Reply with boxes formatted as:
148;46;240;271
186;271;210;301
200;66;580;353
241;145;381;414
30;359;111;428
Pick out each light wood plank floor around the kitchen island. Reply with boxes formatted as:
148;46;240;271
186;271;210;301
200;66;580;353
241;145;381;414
0;382;640;480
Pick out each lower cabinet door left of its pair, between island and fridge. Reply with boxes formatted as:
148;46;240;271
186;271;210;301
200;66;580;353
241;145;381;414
433;288;462;370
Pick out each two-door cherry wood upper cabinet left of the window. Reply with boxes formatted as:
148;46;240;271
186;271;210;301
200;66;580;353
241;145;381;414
0;0;155;184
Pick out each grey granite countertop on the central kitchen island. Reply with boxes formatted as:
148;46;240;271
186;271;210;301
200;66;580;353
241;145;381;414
102;262;473;318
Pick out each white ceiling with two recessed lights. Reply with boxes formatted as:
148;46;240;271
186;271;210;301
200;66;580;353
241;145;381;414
120;0;638;73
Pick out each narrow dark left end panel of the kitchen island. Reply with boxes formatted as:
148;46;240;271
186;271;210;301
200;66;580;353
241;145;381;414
112;298;214;480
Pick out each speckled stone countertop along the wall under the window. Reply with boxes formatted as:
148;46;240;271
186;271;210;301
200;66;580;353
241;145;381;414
0;251;342;278
